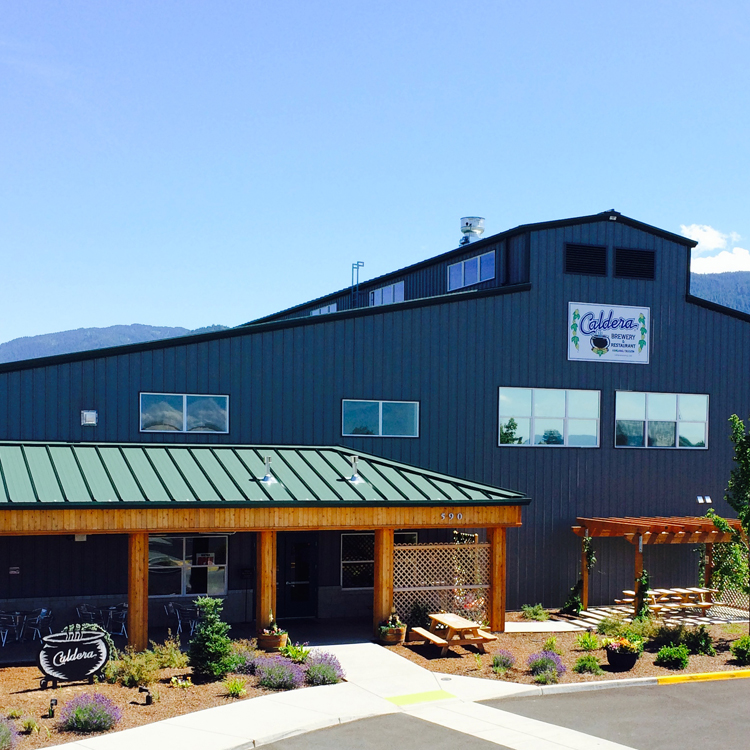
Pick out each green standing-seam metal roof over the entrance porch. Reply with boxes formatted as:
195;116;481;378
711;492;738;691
0;442;530;508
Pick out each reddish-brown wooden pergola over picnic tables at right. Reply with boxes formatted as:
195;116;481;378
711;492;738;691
572;516;742;609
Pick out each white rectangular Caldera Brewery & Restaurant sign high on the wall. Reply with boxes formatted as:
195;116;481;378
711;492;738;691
568;302;651;365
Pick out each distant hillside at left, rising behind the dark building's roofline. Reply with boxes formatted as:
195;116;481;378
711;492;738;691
0;323;227;363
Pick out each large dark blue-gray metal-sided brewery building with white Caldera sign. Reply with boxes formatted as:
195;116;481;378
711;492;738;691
0;211;750;617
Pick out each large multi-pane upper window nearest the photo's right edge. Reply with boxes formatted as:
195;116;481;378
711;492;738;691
615;391;708;448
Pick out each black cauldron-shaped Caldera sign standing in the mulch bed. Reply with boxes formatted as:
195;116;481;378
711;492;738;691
37;630;109;681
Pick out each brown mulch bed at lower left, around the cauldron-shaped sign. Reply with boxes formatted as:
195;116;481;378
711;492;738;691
0;667;276;750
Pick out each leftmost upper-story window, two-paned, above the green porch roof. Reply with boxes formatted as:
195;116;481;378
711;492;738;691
140;393;229;433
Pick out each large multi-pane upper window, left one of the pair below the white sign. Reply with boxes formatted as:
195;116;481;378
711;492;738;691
498;388;599;448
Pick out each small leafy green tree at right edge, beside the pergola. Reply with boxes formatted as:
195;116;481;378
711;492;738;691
708;414;750;636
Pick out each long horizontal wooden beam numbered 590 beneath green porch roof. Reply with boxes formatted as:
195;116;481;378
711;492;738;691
0;503;521;536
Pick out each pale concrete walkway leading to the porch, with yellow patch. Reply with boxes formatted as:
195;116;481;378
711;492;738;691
53;643;628;750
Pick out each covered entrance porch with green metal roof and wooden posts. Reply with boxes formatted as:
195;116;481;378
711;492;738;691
0;443;530;649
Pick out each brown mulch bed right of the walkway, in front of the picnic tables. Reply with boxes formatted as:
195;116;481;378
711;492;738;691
387;624;748;685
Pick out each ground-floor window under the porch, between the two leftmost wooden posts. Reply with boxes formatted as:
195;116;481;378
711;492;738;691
148;536;227;596
